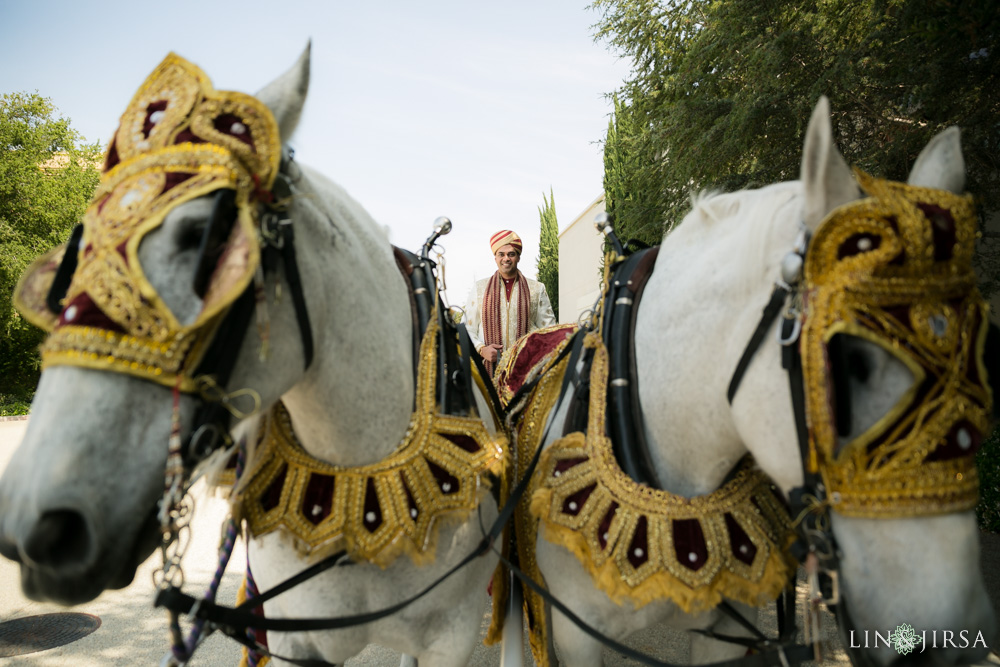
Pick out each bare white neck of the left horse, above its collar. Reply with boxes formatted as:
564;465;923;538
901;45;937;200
282;174;413;465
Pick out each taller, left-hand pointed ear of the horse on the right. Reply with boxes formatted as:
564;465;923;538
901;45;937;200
801;96;861;232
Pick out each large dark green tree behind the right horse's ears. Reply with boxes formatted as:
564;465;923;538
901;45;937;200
592;0;1000;290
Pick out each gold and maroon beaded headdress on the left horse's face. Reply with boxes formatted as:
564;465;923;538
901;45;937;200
15;54;281;391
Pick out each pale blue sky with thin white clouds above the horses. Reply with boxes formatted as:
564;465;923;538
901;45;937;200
0;0;629;305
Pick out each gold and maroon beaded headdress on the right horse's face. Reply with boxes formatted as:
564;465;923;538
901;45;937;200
801;172;992;517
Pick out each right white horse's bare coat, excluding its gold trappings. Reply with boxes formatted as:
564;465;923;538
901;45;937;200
500;98;995;667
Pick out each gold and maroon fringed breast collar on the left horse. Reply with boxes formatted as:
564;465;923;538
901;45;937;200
234;317;507;567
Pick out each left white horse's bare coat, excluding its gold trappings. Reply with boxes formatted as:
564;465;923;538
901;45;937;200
0;49;497;667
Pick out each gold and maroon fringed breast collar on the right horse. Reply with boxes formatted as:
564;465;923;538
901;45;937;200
488;333;796;665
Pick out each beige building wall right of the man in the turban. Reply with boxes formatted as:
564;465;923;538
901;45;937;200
559;194;604;322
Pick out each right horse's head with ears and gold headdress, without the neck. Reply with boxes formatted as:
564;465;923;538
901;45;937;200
801;99;995;664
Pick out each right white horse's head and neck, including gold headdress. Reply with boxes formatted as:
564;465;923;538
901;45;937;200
616;98;994;665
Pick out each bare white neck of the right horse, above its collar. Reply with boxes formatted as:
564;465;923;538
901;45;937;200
635;184;799;497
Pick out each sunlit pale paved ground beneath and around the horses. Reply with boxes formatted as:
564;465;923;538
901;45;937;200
0;421;988;667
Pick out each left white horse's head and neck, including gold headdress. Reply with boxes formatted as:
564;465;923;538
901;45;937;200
0;48;413;604
